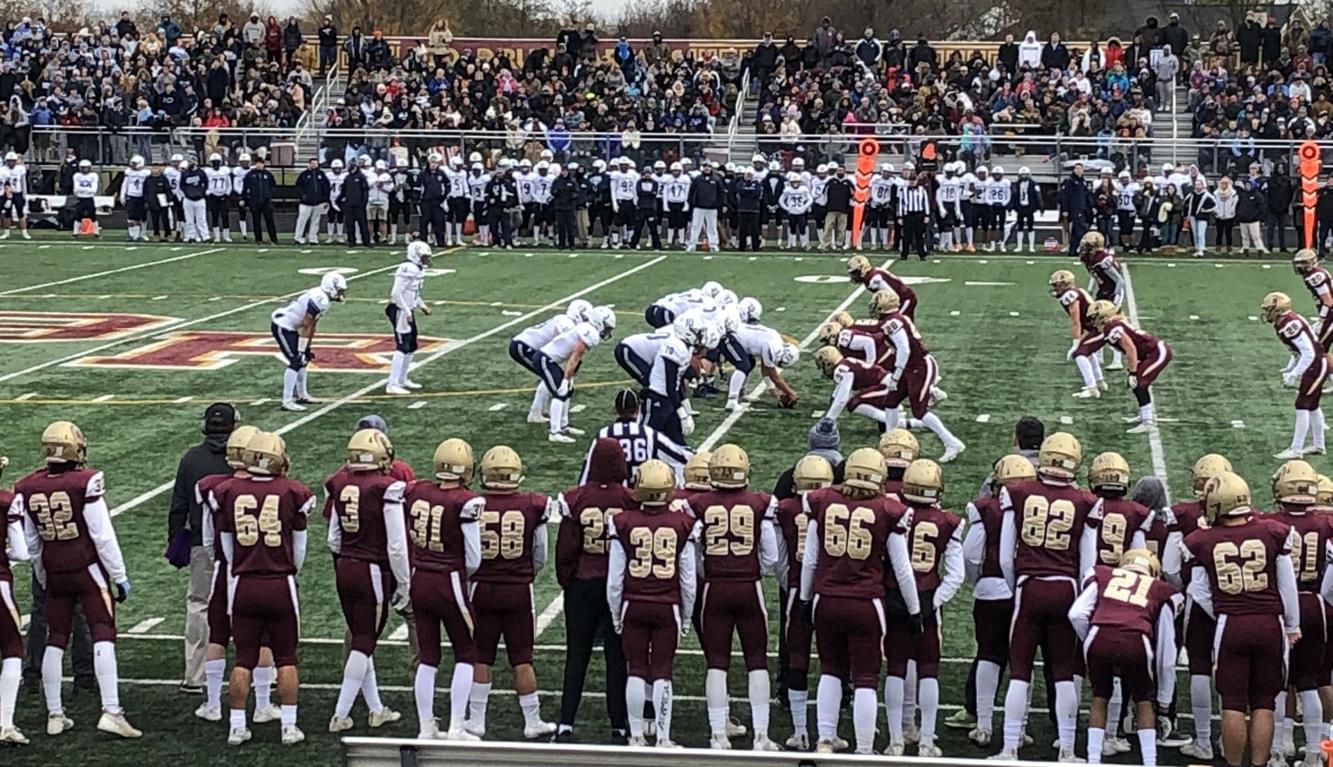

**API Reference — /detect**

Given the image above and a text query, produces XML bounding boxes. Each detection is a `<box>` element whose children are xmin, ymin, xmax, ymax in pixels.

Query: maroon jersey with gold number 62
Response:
<box><xmin>1185</xmin><ymin>516</ymin><xmax>1292</xmax><ymax>615</ymax></box>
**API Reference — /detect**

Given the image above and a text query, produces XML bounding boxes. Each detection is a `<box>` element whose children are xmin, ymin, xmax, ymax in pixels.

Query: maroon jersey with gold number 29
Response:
<box><xmin>688</xmin><ymin>490</ymin><xmax>774</xmax><ymax>580</ymax></box>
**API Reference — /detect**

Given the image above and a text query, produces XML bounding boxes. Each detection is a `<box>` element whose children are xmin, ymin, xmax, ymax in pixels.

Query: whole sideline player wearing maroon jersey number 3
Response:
<box><xmin>324</xmin><ymin>428</ymin><xmax>411</xmax><ymax>732</ymax></box>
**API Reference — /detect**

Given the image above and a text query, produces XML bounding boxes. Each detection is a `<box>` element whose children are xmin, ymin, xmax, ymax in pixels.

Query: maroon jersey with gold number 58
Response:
<box><xmin>472</xmin><ymin>492</ymin><xmax>551</xmax><ymax>584</ymax></box>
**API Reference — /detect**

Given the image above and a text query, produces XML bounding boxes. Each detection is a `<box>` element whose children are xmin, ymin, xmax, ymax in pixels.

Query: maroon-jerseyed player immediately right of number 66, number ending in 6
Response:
<box><xmin>884</xmin><ymin>459</ymin><xmax>964</xmax><ymax>758</ymax></box>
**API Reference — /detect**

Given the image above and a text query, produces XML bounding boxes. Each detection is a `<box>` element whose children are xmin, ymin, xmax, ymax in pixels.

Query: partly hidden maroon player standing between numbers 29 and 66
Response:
<box><xmin>777</xmin><ymin>455</ymin><xmax>845</xmax><ymax>751</ymax></box>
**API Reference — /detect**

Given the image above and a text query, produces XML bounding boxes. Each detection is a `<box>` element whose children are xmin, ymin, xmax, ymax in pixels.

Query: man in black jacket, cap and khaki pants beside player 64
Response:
<box><xmin>167</xmin><ymin>405</ymin><xmax>238</xmax><ymax>692</ymax></box>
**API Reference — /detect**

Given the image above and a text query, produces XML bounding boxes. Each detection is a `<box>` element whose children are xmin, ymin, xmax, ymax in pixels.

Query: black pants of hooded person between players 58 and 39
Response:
<box><xmin>560</xmin><ymin>578</ymin><xmax>629</xmax><ymax>732</ymax></box>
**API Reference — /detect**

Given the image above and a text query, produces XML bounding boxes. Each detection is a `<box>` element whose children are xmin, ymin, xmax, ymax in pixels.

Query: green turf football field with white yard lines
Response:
<box><xmin>0</xmin><ymin>237</ymin><xmax>1329</xmax><ymax>764</ymax></box>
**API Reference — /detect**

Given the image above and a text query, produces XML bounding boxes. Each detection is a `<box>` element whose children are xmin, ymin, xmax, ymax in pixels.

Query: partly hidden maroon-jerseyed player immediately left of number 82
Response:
<box><xmin>962</xmin><ymin>454</ymin><xmax>1037</xmax><ymax>746</ymax></box>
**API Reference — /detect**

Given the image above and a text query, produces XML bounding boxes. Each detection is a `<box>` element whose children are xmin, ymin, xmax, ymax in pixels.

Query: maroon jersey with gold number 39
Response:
<box><xmin>612</xmin><ymin>504</ymin><xmax>694</xmax><ymax>604</ymax></box>
